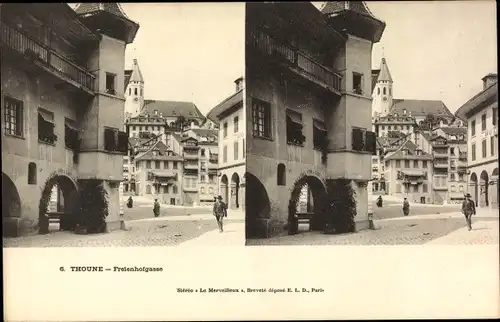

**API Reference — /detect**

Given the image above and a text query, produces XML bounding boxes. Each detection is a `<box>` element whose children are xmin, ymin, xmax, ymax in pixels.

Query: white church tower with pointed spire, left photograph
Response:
<box><xmin>125</xmin><ymin>59</ymin><xmax>144</xmax><ymax>119</ymax></box>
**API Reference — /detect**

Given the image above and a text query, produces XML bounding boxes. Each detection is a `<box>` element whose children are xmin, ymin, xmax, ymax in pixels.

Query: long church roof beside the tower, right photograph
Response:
<box><xmin>390</xmin><ymin>99</ymin><xmax>453</xmax><ymax>118</ymax></box>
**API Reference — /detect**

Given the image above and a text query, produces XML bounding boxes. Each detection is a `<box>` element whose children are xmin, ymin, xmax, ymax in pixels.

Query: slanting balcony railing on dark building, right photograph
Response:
<box><xmin>251</xmin><ymin>30</ymin><xmax>342</xmax><ymax>92</ymax></box>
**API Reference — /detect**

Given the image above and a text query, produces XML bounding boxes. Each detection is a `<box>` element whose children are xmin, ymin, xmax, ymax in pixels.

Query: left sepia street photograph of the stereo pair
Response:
<box><xmin>0</xmin><ymin>3</ymin><xmax>245</xmax><ymax>247</ymax></box>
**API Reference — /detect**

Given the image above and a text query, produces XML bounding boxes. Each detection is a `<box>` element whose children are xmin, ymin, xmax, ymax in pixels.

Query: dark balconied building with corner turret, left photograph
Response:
<box><xmin>0</xmin><ymin>3</ymin><xmax>138</xmax><ymax>236</ymax></box>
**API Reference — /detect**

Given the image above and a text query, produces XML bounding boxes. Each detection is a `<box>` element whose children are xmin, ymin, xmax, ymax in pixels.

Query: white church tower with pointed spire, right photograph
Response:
<box><xmin>372</xmin><ymin>58</ymin><xmax>393</xmax><ymax>117</ymax></box>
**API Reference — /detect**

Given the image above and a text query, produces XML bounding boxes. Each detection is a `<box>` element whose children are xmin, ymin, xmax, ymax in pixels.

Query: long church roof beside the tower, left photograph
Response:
<box><xmin>141</xmin><ymin>100</ymin><xmax>205</xmax><ymax>119</ymax></box>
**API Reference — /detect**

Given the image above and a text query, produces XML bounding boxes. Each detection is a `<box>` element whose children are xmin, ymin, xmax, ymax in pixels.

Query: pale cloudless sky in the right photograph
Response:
<box><xmin>314</xmin><ymin>0</ymin><xmax>497</xmax><ymax>112</ymax></box>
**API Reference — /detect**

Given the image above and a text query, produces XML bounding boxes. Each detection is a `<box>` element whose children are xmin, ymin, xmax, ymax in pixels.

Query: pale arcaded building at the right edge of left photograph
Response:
<box><xmin>207</xmin><ymin>78</ymin><xmax>247</xmax><ymax>210</ymax></box>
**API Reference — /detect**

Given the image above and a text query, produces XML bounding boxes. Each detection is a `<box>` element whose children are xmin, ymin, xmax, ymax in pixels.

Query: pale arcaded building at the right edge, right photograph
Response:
<box><xmin>456</xmin><ymin>74</ymin><xmax>499</xmax><ymax>209</ymax></box>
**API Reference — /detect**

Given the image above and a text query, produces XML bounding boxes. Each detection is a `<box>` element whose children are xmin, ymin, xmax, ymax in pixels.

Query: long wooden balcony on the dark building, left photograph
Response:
<box><xmin>0</xmin><ymin>23</ymin><xmax>95</xmax><ymax>95</ymax></box>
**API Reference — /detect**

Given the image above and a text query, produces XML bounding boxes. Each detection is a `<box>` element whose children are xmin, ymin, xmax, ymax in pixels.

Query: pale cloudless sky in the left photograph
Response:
<box><xmin>120</xmin><ymin>3</ymin><xmax>245</xmax><ymax>115</ymax></box>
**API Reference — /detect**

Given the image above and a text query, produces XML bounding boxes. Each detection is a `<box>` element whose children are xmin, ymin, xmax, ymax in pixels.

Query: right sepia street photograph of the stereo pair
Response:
<box><xmin>245</xmin><ymin>1</ymin><xmax>500</xmax><ymax>245</ymax></box>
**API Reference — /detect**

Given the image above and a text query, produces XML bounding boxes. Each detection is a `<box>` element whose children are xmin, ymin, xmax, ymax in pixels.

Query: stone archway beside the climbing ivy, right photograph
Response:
<box><xmin>288</xmin><ymin>175</ymin><xmax>328</xmax><ymax>233</ymax></box>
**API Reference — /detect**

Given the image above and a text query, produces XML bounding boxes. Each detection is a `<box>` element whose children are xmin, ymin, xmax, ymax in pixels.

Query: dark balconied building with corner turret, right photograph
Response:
<box><xmin>245</xmin><ymin>1</ymin><xmax>385</xmax><ymax>237</ymax></box>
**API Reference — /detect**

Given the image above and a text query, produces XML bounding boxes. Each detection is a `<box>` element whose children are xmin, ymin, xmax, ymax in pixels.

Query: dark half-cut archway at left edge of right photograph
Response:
<box><xmin>245</xmin><ymin>172</ymin><xmax>271</xmax><ymax>238</ymax></box>
